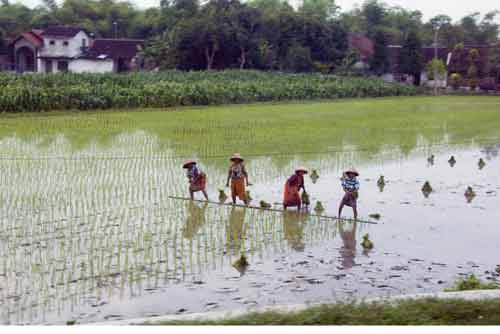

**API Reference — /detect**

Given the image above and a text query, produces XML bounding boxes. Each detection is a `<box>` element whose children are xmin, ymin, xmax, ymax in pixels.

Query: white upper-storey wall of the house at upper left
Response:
<box><xmin>40</xmin><ymin>31</ymin><xmax>90</xmax><ymax>58</ymax></box>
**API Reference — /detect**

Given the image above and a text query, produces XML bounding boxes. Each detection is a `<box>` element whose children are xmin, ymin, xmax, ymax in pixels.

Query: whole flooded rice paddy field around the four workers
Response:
<box><xmin>0</xmin><ymin>97</ymin><xmax>500</xmax><ymax>324</ymax></box>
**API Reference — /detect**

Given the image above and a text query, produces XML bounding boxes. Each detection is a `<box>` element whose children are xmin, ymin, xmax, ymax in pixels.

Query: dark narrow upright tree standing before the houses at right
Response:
<box><xmin>400</xmin><ymin>30</ymin><xmax>423</xmax><ymax>86</ymax></box>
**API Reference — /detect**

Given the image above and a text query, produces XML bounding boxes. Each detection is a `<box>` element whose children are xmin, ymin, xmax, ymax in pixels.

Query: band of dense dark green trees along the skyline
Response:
<box><xmin>0</xmin><ymin>0</ymin><xmax>500</xmax><ymax>76</ymax></box>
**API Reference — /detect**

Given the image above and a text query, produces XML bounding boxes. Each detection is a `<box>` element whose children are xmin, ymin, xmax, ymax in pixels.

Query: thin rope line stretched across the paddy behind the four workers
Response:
<box><xmin>0</xmin><ymin>139</ymin><xmax>495</xmax><ymax>161</ymax></box>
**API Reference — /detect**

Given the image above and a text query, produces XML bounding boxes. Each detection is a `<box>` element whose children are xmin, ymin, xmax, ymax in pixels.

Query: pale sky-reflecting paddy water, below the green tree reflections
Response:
<box><xmin>0</xmin><ymin>108</ymin><xmax>500</xmax><ymax>324</ymax></box>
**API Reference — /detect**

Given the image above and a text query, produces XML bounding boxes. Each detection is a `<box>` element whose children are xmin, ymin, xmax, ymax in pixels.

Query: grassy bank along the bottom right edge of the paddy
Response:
<box><xmin>149</xmin><ymin>299</ymin><xmax>500</xmax><ymax>325</ymax></box>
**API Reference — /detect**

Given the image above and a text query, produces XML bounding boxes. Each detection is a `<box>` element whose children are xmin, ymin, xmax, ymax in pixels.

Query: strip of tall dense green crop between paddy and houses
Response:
<box><xmin>0</xmin><ymin>71</ymin><xmax>416</xmax><ymax>112</ymax></box>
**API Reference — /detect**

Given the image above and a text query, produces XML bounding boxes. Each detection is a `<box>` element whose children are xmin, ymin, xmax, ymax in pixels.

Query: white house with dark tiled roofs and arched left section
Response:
<box><xmin>11</xmin><ymin>26</ymin><xmax>144</xmax><ymax>73</ymax></box>
